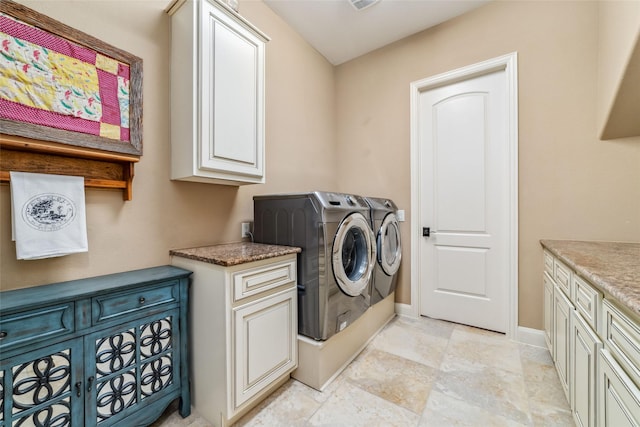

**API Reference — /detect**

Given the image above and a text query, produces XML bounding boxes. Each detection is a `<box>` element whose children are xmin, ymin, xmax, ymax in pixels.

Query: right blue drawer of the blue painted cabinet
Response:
<box><xmin>91</xmin><ymin>282</ymin><xmax>179</xmax><ymax>325</ymax></box>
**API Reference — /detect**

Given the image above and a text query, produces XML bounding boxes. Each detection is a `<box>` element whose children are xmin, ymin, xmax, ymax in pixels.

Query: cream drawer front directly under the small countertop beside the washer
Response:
<box><xmin>232</xmin><ymin>258</ymin><xmax>296</xmax><ymax>301</ymax></box>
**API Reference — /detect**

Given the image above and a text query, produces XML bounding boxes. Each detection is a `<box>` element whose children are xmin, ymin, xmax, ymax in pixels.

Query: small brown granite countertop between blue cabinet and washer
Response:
<box><xmin>169</xmin><ymin>242</ymin><xmax>302</xmax><ymax>267</ymax></box>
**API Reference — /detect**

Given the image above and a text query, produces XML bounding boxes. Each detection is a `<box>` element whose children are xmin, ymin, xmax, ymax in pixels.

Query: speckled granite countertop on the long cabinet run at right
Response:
<box><xmin>540</xmin><ymin>240</ymin><xmax>640</xmax><ymax>315</ymax></box>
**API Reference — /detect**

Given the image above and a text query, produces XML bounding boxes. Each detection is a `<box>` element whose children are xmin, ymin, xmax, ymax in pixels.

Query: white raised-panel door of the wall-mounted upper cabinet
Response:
<box><xmin>199</xmin><ymin>1</ymin><xmax>265</xmax><ymax>178</ymax></box>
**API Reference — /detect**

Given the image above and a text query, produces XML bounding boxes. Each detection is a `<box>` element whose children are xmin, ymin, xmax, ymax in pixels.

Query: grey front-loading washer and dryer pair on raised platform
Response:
<box><xmin>254</xmin><ymin>191</ymin><xmax>401</xmax><ymax>340</ymax></box>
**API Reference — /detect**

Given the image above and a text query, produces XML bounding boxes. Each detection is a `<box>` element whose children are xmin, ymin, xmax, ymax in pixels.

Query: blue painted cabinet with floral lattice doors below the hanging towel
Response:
<box><xmin>0</xmin><ymin>266</ymin><xmax>191</xmax><ymax>427</ymax></box>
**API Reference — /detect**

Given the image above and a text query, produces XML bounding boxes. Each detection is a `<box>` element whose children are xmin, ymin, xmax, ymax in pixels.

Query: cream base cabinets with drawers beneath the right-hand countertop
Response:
<box><xmin>543</xmin><ymin>250</ymin><xmax>640</xmax><ymax>427</ymax></box>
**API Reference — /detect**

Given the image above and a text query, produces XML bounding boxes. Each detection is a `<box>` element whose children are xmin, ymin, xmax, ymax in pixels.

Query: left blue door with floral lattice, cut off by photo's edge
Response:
<box><xmin>0</xmin><ymin>339</ymin><xmax>84</xmax><ymax>427</ymax></box>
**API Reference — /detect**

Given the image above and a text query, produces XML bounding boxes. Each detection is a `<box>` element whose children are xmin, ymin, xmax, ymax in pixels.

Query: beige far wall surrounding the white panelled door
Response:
<box><xmin>336</xmin><ymin>1</ymin><xmax>640</xmax><ymax>329</ymax></box>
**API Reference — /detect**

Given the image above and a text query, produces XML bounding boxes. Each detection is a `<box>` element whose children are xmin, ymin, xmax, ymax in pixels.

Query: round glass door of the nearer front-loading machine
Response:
<box><xmin>332</xmin><ymin>212</ymin><xmax>376</xmax><ymax>297</ymax></box>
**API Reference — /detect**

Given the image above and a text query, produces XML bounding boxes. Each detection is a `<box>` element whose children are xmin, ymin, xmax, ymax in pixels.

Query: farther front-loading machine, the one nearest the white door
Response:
<box><xmin>364</xmin><ymin>197</ymin><xmax>402</xmax><ymax>305</ymax></box>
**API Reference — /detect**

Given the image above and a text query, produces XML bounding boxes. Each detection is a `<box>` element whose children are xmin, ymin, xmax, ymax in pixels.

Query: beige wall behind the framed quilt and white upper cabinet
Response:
<box><xmin>0</xmin><ymin>0</ymin><xmax>337</xmax><ymax>290</ymax></box>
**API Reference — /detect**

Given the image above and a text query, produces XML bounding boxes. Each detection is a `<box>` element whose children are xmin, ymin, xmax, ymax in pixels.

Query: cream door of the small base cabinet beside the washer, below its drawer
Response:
<box><xmin>232</xmin><ymin>288</ymin><xmax>297</xmax><ymax>409</ymax></box>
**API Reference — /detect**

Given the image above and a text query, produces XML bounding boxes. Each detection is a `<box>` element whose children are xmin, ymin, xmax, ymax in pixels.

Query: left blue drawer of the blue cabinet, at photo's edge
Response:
<box><xmin>0</xmin><ymin>302</ymin><xmax>74</xmax><ymax>350</ymax></box>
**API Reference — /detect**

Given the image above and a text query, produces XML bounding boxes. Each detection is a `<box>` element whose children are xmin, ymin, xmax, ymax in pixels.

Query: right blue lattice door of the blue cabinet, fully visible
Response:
<box><xmin>85</xmin><ymin>310</ymin><xmax>180</xmax><ymax>426</ymax></box>
